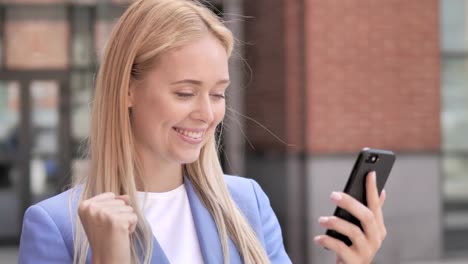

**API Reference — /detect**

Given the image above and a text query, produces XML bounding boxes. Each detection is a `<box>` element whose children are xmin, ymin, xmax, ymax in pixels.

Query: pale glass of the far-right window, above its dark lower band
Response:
<box><xmin>441</xmin><ymin>0</ymin><xmax>468</xmax><ymax>202</ymax></box>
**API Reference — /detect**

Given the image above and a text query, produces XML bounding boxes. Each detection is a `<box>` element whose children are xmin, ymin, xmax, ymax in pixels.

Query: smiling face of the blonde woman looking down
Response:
<box><xmin>129</xmin><ymin>34</ymin><xmax>229</xmax><ymax>164</ymax></box>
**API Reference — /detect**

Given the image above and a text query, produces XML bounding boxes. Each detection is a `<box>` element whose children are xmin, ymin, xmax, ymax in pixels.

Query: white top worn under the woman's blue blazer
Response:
<box><xmin>137</xmin><ymin>184</ymin><xmax>203</xmax><ymax>264</ymax></box>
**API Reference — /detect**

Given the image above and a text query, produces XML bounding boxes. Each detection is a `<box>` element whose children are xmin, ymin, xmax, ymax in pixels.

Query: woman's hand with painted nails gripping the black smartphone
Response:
<box><xmin>314</xmin><ymin>172</ymin><xmax>387</xmax><ymax>264</ymax></box>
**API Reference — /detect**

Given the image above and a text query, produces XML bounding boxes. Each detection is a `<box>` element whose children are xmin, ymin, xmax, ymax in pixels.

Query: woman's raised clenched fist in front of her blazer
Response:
<box><xmin>78</xmin><ymin>193</ymin><xmax>138</xmax><ymax>264</ymax></box>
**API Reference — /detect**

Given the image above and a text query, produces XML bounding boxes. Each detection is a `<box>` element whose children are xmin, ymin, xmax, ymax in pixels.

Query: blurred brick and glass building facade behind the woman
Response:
<box><xmin>0</xmin><ymin>0</ymin><xmax>468</xmax><ymax>264</ymax></box>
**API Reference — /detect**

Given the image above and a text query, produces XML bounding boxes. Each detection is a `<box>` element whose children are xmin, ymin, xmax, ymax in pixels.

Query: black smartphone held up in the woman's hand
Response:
<box><xmin>326</xmin><ymin>148</ymin><xmax>395</xmax><ymax>246</ymax></box>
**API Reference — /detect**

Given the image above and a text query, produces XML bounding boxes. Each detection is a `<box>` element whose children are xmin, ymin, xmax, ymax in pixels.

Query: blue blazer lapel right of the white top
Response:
<box><xmin>184</xmin><ymin>177</ymin><xmax>242</xmax><ymax>264</ymax></box>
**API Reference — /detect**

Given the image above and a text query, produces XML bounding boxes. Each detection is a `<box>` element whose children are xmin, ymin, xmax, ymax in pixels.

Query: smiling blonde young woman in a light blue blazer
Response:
<box><xmin>19</xmin><ymin>0</ymin><xmax>385</xmax><ymax>264</ymax></box>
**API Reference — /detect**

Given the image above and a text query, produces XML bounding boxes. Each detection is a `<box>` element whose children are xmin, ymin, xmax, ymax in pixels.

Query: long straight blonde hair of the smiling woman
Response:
<box><xmin>73</xmin><ymin>0</ymin><xmax>269</xmax><ymax>263</ymax></box>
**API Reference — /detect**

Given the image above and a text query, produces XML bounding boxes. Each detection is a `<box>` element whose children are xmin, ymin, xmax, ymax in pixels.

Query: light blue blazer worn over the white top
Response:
<box><xmin>19</xmin><ymin>176</ymin><xmax>291</xmax><ymax>264</ymax></box>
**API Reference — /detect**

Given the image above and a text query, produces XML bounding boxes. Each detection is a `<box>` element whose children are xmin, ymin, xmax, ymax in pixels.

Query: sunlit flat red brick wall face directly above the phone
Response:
<box><xmin>305</xmin><ymin>0</ymin><xmax>440</xmax><ymax>153</ymax></box>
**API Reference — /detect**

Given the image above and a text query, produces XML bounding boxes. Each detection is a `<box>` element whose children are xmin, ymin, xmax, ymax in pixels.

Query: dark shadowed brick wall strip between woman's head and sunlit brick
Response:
<box><xmin>243</xmin><ymin>0</ymin><xmax>287</xmax><ymax>151</ymax></box>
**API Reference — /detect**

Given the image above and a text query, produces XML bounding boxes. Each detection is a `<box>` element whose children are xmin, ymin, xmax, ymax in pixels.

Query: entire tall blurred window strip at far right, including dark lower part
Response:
<box><xmin>440</xmin><ymin>0</ymin><xmax>468</xmax><ymax>255</ymax></box>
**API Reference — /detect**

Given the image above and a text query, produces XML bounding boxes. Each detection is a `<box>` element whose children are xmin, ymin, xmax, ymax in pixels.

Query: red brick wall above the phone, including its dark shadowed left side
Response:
<box><xmin>245</xmin><ymin>0</ymin><xmax>440</xmax><ymax>154</ymax></box>
